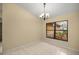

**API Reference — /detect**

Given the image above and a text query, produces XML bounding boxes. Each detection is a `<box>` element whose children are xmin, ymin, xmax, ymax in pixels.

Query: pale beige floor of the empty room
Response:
<box><xmin>4</xmin><ymin>42</ymin><xmax>79</xmax><ymax>55</ymax></box>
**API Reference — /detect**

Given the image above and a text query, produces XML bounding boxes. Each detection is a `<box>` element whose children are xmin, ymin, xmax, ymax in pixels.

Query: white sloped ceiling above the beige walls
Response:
<box><xmin>17</xmin><ymin>3</ymin><xmax>79</xmax><ymax>18</ymax></box>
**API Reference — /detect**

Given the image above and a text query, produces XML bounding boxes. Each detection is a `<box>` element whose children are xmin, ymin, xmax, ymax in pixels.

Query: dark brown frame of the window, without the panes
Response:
<box><xmin>46</xmin><ymin>20</ymin><xmax>68</xmax><ymax>41</ymax></box>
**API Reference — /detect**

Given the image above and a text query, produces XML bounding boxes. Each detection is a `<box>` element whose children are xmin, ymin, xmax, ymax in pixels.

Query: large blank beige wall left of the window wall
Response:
<box><xmin>3</xmin><ymin>4</ymin><xmax>42</xmax><ymax>51</ymax></box>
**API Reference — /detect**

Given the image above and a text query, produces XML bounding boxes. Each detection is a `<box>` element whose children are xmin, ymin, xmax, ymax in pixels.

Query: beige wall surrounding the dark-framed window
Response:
<box><xmin>43</xmin><ymin>12</ymin><xmax>79</xmax><ymax>50</ymax></box>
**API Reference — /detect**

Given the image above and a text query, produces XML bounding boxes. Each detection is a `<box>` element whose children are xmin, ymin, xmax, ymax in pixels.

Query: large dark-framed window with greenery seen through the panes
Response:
<box><xmin>46</xmin><ymin>20</ymin><xmax>68</xmax><ymax>41</ymax></box>
